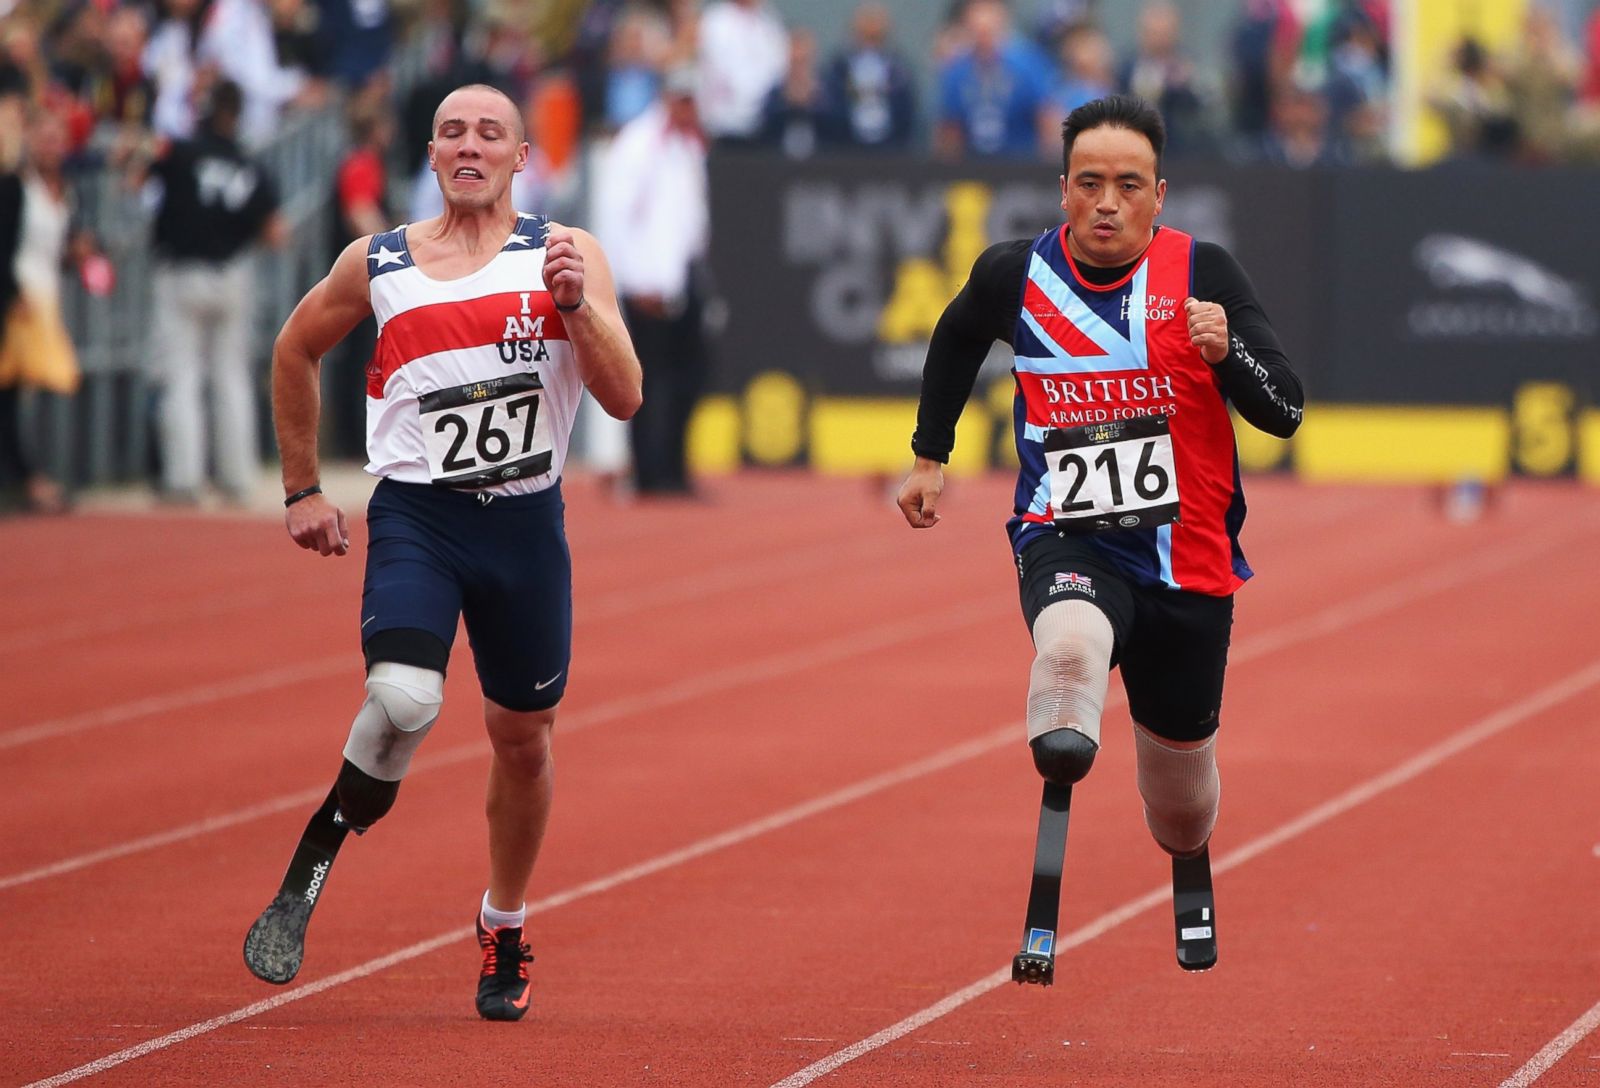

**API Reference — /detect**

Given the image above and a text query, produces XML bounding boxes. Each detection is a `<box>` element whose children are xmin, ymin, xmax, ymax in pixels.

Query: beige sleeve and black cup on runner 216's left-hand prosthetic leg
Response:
<box><xmin>1027</xmin><ymin>600</ymin><xmax>1115</xmax><ymax>786</ymax></box>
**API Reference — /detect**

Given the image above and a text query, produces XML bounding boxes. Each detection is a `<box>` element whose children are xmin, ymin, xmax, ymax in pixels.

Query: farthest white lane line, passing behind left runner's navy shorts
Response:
<box><xmin>0</xmin><ymin>537</ymin><xmax>908</xmax><ymax>750</ymax></box>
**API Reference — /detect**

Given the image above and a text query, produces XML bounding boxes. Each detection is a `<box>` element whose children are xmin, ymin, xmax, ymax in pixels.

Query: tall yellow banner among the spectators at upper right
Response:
<box><xmin>1390</xmin><ymin>0</ymin><xmax>1528</xmax><ymax>166</ymax></box>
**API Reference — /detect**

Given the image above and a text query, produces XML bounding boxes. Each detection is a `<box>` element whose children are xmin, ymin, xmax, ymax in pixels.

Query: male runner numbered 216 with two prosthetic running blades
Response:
<box><xmin>899</xmin><ymin>96</ymin><xmax>1304</xmax><ymax>984</ymax></box>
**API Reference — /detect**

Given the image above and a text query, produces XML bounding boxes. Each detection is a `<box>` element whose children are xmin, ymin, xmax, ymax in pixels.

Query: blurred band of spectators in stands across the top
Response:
<box><xmin>0</xmin><ymin>0</ymin><xmax>1600</xmax><ymax>173</ymax></box>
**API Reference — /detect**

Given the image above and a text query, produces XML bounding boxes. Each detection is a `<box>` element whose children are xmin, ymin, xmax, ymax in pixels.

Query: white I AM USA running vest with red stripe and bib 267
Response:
<box><xmin>366</xmin><ymin>214</ymin><xmax>582</xmax><ymax>494</ymax></box>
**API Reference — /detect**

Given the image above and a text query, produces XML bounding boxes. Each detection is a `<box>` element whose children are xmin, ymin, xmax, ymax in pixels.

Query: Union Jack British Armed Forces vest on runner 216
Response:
<box><xmin>1006</xmin><ymin>226</ymin><xmax>1251</xmax><ymax>597</ymax></box>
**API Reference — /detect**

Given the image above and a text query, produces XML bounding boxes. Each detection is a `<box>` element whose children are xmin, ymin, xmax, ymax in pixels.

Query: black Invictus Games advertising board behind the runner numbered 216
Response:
<box><xmin>710</xmin><ymin>152</ymin><xmax>1326</xmax><ymax>397</ymax></box>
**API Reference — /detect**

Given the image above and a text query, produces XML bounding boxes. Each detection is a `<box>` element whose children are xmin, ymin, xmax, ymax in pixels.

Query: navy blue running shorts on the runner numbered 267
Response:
<box><xmin>362</xmin><ymin>480</ymin><xmax>573</xmax><ymax>710</ymax></box>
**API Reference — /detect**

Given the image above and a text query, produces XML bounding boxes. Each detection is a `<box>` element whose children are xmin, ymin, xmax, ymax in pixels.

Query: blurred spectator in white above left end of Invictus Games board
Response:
<box><xmin>698</xmin><ymin>0</ymin><xmax>789</xmax><ymax>142</ymax></box>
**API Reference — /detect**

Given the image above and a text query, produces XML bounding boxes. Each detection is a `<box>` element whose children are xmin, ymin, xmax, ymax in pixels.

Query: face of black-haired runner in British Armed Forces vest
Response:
<box><xmin>1061</xmin><ymin>125</ymin><xmax>1166</xmax><ymax>267</ymax></box>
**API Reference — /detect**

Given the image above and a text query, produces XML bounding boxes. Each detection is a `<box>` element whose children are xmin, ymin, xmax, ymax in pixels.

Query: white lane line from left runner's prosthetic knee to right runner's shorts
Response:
<box><xmin>0</xmin><ymin>597</ymin><xmax>1013</xmax><ymax>891</ymax></box>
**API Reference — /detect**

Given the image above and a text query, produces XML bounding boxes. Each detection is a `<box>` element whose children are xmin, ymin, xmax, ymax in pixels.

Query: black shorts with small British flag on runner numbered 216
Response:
<box><xmin>1016</xmin><ymin>534</ymin><xmax>1234</xmax><ymax>741</ymax></box>
